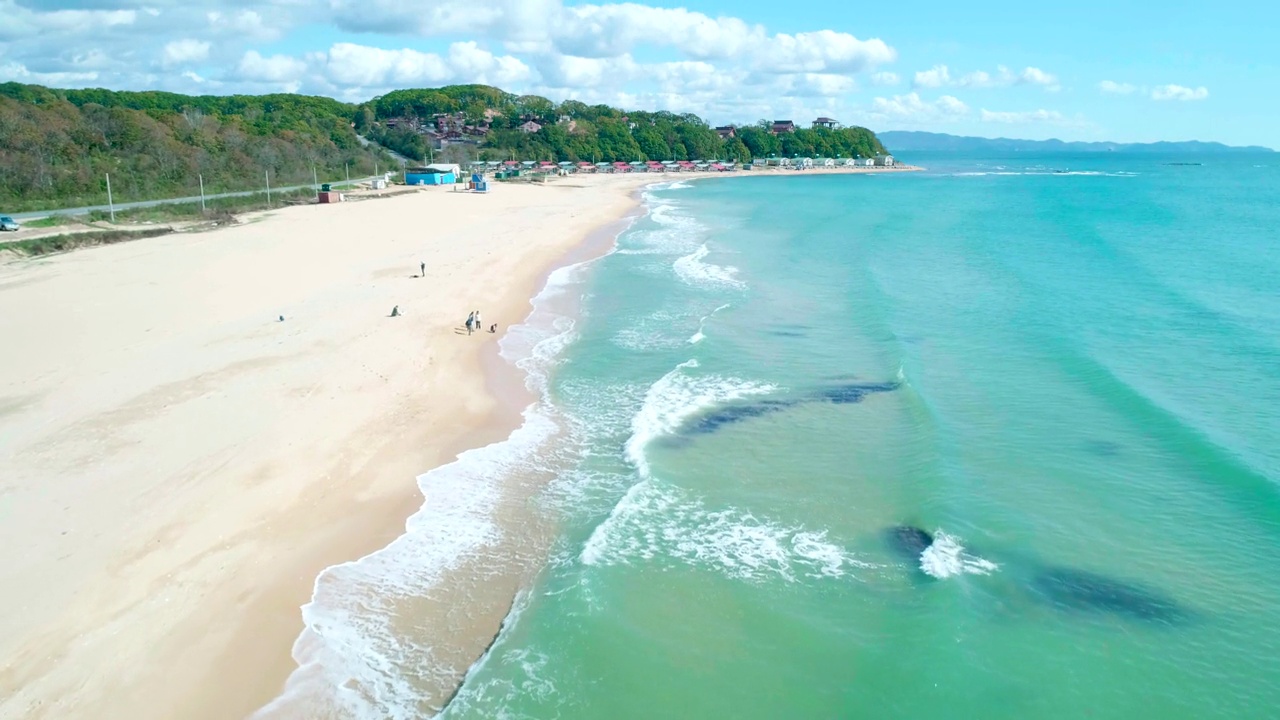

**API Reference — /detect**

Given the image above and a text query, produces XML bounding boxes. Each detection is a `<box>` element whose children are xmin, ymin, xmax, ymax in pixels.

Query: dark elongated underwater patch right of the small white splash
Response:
<box><xmin>1032</xmin><ymin>568</ymin><xmax>1187</xmax><ymax>623</ymax></box>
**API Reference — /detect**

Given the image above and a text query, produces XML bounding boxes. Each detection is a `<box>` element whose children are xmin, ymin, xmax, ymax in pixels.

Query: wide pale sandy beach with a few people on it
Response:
<box><xmin>0</xmin><ymin>163</ymin><xmax>911</xmax><ymax>719</ymax></box>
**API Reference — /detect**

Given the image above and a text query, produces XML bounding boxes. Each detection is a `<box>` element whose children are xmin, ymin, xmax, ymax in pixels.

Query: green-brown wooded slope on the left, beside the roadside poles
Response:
<box><xmin>0</xmin><ymin>83</ymin><xmax>389</xmax><ymax>213</ymax></box>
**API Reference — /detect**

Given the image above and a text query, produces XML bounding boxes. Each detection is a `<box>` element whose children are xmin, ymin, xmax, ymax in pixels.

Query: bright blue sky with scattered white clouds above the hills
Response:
<box><xmin>0</xmin><ymin>0</ymin><xmax>1280</xmax><ymax>147</ymax></box>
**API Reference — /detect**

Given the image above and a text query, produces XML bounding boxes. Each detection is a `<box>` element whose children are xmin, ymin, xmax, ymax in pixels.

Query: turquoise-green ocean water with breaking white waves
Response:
<box><xmin>257</xmin><ymin>155</ymin><xmax>1280</xmax><ymax>720</ymax></box>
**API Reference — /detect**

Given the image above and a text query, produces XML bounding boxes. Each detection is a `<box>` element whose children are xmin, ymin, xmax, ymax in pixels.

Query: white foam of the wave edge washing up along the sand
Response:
<box><xmin>252</xmin><ymin>203</ymin><xmax>629</xmax><ymax>720</ymax></box>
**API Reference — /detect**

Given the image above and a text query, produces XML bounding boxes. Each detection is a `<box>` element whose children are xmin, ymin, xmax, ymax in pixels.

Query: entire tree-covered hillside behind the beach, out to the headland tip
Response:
<box><xmin>0</xmin><ymin>82</ymin><xmax>884</xmax><ymax>213</ymax></box>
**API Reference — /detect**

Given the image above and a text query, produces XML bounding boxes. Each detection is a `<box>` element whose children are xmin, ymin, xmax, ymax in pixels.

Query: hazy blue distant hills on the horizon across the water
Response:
<box><xmin>876</xmin><ymin>131</ymin><xmax>1274</xmax><ymax>154</ymax></box>
